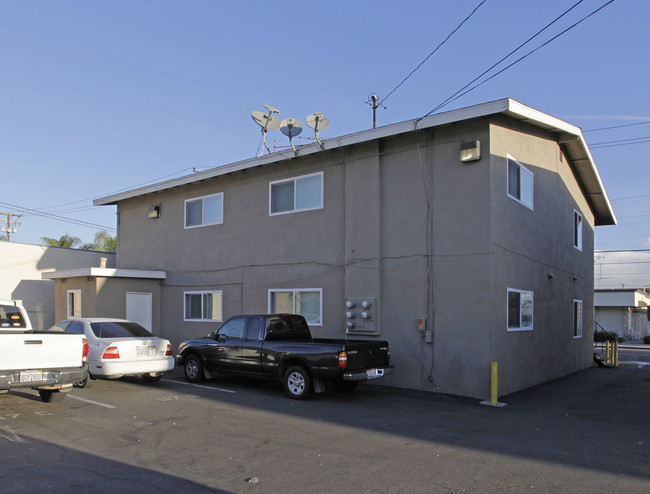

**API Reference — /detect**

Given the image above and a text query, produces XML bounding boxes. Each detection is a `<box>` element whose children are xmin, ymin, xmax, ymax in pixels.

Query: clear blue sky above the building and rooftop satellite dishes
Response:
<box><xmin>0</xmin><ymin>0</ymin><xmax>650</xmax><ymax>250</ymax></box>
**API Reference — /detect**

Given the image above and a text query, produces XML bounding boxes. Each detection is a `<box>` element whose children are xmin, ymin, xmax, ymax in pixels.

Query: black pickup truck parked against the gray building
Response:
<box><xmin>176</xmin><ymin>314</ymin><xmax>393</xmax><ymax>400</ymax></box>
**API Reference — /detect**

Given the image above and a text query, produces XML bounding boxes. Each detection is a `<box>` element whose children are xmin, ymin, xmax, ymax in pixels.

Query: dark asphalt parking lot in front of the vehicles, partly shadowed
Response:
<box><xmin>0</xmin><ymin>350</ymin><xmax>650</xmax><ymax>494</ymax></box>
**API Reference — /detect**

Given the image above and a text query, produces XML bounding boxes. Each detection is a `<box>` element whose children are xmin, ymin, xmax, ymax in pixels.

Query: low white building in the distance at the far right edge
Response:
<box><xmin>594</xmin><ymin>288</ymin><xmax>650</xmax><ymax>340</ymax></box>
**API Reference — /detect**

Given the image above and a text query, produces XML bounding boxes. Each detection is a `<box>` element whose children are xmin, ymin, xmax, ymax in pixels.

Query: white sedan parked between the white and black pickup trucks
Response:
<box><xmin>50</xmin><ymin>317</ymin><xmax>174</xmax><ymax>387</ymax></box>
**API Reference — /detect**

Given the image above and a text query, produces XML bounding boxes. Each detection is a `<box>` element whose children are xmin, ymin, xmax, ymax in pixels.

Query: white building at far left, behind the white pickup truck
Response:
<box><xmin>0</xmin><ymin>241</ymin><xmax>115</xmax><ymax>330</ymax></box>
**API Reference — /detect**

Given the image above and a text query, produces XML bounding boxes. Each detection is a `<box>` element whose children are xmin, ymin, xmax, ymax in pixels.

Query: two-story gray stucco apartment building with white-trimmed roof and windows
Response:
<box><xmin>71</xmin><ymin>99</ymin><xmax>616</xmax><ymax>398</ymax></box>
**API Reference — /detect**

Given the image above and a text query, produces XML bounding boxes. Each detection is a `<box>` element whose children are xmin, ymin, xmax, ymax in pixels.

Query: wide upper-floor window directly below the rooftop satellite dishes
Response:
<box><xmin>269</xmin><ymin>172</ymin><xmax>323</xmax><ymax>215</ymax></box>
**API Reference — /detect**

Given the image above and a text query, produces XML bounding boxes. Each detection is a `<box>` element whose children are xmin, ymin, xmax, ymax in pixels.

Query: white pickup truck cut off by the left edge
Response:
<box><xmin>0</xmin><ymin>299</ymin><xmax>88</xmax><ymax>403</ymax></box>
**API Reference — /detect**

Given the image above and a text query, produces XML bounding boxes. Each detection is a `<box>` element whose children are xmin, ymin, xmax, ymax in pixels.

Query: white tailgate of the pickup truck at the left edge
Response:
<box><xmin>0</xmin><ymin>331</ymin><xmax>83</xmax><ymax>369</ymax></box>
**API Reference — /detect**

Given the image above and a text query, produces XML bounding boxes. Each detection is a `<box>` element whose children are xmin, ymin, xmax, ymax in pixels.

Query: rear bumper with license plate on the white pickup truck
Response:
<box><xmin>0</xmin><ymin>362</ymin><xmax>88</xmax><ymax>390</ymax></box>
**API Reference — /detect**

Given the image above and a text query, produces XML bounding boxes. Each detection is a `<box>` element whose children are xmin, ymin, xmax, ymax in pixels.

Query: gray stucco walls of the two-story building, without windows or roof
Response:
<box><xmin>109</xmin><ymin>118</ymin><xmax>594</xmax><ymax>398</ymax></box>
